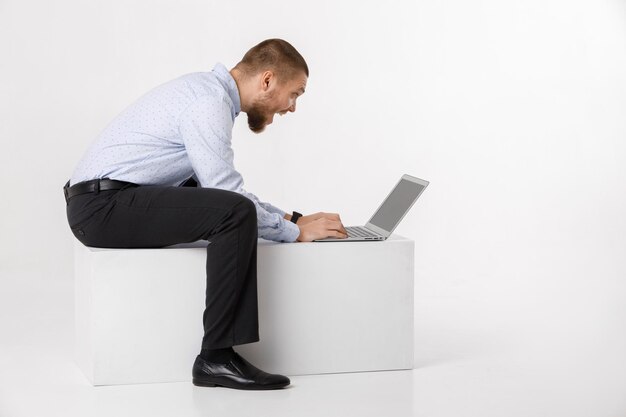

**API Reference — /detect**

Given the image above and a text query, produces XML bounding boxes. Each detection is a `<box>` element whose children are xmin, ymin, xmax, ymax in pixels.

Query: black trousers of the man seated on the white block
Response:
<box><xmin>67</xmin><ymin>181</ymin><xmax>259</xmax><ymax>349</ymax></box>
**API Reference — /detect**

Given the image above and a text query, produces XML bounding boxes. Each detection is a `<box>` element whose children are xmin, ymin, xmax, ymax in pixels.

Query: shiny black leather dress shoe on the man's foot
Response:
<box><xmin>192</xmin><ymin>352</ymin><xmax>291</xmax><ymax>390</ymax></box>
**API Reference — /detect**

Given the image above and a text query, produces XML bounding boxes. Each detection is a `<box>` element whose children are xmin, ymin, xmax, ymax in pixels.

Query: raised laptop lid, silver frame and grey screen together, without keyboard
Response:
<box><xmin>365</xmin><ymin>174</ymin><xmax>429</xmax><ymax>237</ymax></box>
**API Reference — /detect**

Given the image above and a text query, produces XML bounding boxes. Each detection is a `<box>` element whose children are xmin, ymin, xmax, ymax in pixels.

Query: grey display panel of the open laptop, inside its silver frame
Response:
<box><xmin>369</xmin><ymin>179</ymin><xmax>426</xmax><ymax>232</ymax></box>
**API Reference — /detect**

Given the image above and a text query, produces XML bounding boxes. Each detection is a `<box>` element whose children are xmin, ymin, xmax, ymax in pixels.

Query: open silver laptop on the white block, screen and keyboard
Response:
<box><xmin>313</xmin><ymin>174</ymin><xmax>429</xmax><ymax>242</ymax></box>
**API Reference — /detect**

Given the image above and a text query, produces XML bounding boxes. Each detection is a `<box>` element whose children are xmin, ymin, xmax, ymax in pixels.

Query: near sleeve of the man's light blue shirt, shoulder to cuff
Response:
<box><xmin>179</xmin><ymin>92</ymin><xmax>300</xmax><ymax>242</ymax></box>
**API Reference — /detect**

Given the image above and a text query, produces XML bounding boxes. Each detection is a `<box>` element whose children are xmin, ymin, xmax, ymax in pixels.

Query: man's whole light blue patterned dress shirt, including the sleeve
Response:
<box><xmin>70</xmin><ymin>63</ymin><xmax>300</xmax><ymax>242</ymax></box>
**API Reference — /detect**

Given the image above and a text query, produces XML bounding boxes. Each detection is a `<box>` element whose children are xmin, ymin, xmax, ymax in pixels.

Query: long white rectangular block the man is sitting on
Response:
<box><xmin>75</xmin><ymin>235</ymin><xmax>414</xmax><ymax>385</ymax></box>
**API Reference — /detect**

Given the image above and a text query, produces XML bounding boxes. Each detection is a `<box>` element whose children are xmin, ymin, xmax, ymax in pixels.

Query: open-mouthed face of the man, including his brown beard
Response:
<box><xmin>247</xmin><ymin>71</ymin><xmax>307</xmax><ymax>133</ymax></box>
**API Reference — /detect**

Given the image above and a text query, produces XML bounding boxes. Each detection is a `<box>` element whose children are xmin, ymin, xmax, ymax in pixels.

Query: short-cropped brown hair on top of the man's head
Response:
<box><xmin>235</xmin><ymin>39</ymin><xmax>309</xmax><ymax>79</ymax></box>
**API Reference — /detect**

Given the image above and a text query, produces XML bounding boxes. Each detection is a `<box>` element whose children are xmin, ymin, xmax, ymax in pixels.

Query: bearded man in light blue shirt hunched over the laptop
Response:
<box><xmin>64</xmin><ymin>39</ymin><xmax>347</xmax><ymax>389</ymax></box>
